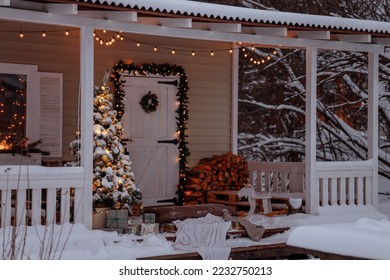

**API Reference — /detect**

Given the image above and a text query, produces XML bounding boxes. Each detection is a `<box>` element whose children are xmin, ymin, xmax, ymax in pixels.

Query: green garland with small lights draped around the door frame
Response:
<box><xmin>111</xmin><ymin>61</ymin><xmax>190</xmax><ymax>205</ymax></box>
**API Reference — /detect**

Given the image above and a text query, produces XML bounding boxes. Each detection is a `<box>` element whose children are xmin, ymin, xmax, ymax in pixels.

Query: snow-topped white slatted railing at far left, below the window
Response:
<box><xmin>0</xmin><ymin>165</ymin><xmax>85</xmax><ymax>227</ymax></box>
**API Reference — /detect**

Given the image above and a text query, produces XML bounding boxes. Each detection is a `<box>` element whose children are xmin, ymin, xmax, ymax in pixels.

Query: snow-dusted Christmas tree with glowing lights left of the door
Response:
<box><xmin>67</xmin><ymin>73</ymin><xmax>142</xmax><ymax>213</ymax></box>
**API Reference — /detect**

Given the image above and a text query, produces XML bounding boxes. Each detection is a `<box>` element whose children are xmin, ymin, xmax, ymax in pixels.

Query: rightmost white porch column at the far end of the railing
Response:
<box><xmin>366</xmin><ymin>52</ymin><xmax>379</xmax><ymax>205</ymax></box>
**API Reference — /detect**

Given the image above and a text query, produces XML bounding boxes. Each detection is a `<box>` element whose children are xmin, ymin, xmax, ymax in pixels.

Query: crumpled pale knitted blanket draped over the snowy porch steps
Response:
<box><xmin>173</xmin><ymin>214</ymin><xmax>231</xmax><ymax>260</ymax></box>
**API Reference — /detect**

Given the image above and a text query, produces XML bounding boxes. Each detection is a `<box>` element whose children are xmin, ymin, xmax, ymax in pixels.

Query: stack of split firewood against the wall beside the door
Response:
<box><xmin>184</xmin><ymin>153</ymin><xmax>249</xmax><ymax>204</ymax></box>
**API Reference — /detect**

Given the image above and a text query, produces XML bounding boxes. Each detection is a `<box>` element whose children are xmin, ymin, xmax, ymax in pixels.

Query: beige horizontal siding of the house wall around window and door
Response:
<box><xmin>0</xmin><ymin>22</ymin><xmax>231</xmax><ymax>166</ymax></box>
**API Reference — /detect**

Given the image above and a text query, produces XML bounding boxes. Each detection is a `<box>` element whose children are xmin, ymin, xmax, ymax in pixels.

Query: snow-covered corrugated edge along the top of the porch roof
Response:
<box><xmin>77</xmin><ymin>0</ymin><xmax>390</xmax><ymax>35</ymax></box>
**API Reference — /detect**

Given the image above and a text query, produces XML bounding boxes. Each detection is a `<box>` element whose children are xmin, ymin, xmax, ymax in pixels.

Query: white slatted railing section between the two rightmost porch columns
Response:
<box><xmin>315</xmin><ymin>160</ymin><xmax>373</xmax><ymax>206</ymax></box>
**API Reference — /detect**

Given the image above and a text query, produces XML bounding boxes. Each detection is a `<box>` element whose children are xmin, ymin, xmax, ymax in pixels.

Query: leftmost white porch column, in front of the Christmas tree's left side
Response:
<box><xmin>80</xmin><ymin>26</ymin><xmax>94</xmax><ymax>229</ymax></box>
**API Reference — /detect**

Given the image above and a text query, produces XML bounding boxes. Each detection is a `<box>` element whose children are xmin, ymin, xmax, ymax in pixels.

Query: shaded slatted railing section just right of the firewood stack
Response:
<box><xmin>248</xmin><ymin>161</ymin><xmax>305</xmax><ymax>192</ymax></box>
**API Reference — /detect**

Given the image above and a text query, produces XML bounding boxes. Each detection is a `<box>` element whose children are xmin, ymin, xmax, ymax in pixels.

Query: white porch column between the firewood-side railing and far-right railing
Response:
<box><xmin>305</xmin><ymin>48</ymin><xmax>319</xmax><ymax>214</ymax></box>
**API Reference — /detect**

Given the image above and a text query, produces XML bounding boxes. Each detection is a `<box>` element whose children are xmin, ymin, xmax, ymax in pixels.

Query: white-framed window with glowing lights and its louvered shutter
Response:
<box><xmin>0</xmin><ymin>63</ymin><xmax>63</xmax><ymax>157</ymax></box>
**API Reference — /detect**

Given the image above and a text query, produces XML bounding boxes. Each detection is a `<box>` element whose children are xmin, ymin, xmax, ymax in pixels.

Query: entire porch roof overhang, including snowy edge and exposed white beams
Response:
<box><xmin>0</xmin><ymin>0</ymin><xmax>390</xmax><ymax>50</ymax></box>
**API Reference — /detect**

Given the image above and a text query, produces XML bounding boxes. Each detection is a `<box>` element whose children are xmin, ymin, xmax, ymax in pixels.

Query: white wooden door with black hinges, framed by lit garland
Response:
<box><xmin>122</xmin><ymin>76</ymin><xmax>179</xmax><ymax>206</ymax></box>
